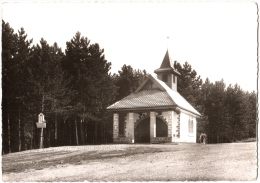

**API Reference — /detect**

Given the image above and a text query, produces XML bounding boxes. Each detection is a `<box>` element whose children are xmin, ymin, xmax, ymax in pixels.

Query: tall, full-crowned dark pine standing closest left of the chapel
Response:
<box><xmin>62</xmin><ymin>32</ymin><xmax>115</xmax><ymax>144</ymax></box>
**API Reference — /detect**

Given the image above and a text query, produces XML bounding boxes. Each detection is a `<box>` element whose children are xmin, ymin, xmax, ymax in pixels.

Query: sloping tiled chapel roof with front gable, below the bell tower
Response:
<box><xmin>107</xmin><ymin>75</ymin><xmax>200</xmax><ymax>116</ymax></box>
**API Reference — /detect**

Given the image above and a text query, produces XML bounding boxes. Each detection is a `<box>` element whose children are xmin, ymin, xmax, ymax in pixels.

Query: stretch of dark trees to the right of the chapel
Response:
<box><xmin>174</xmin><ymin>62</ymin><xmax>257</xmax><ymax>143</ymax></box>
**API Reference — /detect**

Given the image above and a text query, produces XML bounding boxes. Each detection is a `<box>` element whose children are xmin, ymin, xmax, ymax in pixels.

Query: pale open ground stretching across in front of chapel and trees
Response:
<box><xmin>2</xmin><ymin>142</ymin><xmax>257</xmax><ymax>182</ymax></box>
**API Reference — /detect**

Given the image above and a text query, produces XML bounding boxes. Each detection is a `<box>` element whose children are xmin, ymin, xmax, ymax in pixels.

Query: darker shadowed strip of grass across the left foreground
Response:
<box><xmin>2</xmin><ymin>147</ymin><xmax>165</xmax><ymax>173</ymax></box>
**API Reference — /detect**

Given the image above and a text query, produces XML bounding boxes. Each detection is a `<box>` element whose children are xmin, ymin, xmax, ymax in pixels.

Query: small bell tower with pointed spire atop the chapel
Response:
<box><xmin>154</xmin><ymin>50</ymin><xmax>181</xmax><ymax>92</ymax></box>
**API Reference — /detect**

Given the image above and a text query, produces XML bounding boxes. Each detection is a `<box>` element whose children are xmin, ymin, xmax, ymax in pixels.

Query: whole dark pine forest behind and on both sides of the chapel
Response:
<box><xmin>2</xmin><ymin>21</ymin><xmax>257</xmax><ymax>154</ymax></box>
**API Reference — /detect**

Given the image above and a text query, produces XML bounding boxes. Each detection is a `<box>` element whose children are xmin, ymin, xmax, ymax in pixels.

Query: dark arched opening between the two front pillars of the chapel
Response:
<box><xmin>135</xmin><ymin>118</ymin><xmax>150</xmax><ymax>143</ymax></box>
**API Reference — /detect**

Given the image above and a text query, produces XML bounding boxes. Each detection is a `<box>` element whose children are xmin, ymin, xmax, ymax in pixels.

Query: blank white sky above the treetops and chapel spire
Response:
<box><xmin>1</xmin><ymin>0</ymin><xmax>258</xmax><ymax>92</ymax></box>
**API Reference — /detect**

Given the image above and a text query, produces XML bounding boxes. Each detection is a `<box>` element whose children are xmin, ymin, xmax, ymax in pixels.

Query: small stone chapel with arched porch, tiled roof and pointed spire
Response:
<box><xmin>107</xmin><ymin>50</ymin><xmax>201</xmax><ymax>143</ymax></box>
